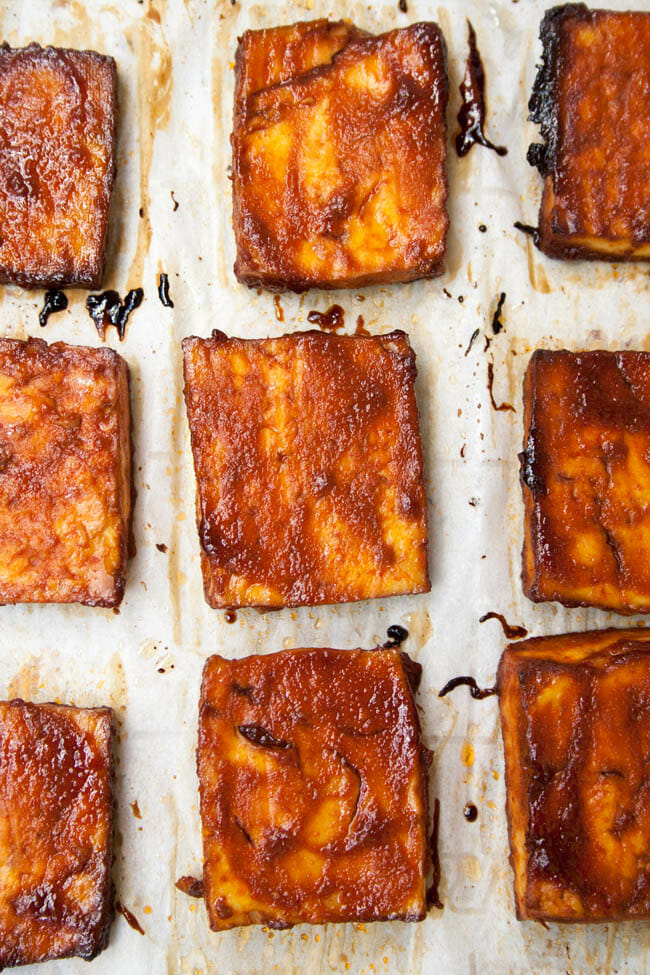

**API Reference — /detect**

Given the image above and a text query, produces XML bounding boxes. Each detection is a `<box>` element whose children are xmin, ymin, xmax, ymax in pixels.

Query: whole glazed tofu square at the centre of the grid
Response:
<box><xmin>183</xmin><ymin>331</ymin><xmax>430</xmax><ymax>607</ymax></box>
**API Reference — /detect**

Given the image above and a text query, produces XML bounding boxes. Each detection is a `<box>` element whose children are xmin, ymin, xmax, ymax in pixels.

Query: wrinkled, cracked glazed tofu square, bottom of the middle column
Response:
<box><xmin>197</xmin><ymin>649</ymin><xmax>430</xmax><ymax>931</ymax></box>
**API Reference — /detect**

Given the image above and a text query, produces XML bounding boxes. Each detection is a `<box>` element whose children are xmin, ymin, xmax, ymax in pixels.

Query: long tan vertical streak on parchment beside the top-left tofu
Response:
<box><xmin>126</xmin><ymin>2</ymin><xmax>173</xmax><ymax>290</ymax></box>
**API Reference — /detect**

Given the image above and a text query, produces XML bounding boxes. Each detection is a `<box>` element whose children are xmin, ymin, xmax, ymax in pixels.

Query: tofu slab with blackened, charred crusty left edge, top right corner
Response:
<box><xmin>528</xmin><ymin>4</ymin><xmax>650</xmax><ymax>261</ymax></box>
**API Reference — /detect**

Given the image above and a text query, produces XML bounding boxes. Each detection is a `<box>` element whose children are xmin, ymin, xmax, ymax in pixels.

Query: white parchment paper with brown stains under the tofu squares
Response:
<box><xmin>0</xmin><ymin>0</ymin><xmax>650</xmax><ymax>975</ymax></box>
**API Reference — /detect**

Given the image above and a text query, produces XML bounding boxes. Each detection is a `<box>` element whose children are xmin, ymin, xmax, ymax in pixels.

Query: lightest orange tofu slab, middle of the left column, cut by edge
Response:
<box><xmin>0</xmin><ymin>339</ymin><xmax>131</xmax><ymax>606</ymax></box>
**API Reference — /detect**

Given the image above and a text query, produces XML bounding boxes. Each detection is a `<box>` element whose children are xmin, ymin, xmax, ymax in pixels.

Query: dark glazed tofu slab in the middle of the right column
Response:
<box><xmin>520</xmin><ymin>350</ymin><xmax>650</xmax><ymax>614</ymax></box>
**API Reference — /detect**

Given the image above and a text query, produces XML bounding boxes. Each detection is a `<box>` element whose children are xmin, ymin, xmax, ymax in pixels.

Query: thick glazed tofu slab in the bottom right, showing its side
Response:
<box><xmin>497</xmin><ymin>629</ymin><xmax>650</xmax><ymax>921</ymax></box>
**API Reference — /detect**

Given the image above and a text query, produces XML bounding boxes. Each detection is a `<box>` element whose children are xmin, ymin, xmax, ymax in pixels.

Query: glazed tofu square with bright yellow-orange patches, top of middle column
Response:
<box><xmin>232</xmin><ymin>20</ymin><xmax>448</xmax><ymax>291</ymax></box>
